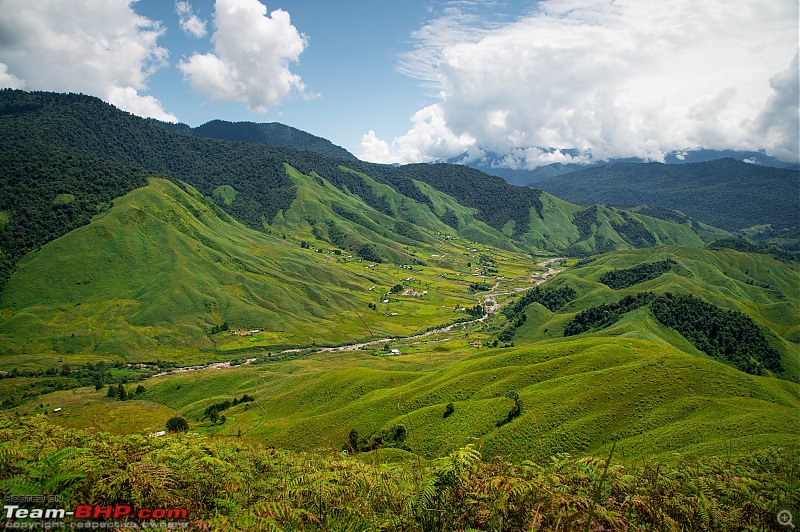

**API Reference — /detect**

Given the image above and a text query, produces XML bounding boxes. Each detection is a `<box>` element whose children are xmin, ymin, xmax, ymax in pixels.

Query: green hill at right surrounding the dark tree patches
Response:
<box><xmin>515</xmin><ymin>246</ymin><xmax>800</xmax><ymax>381</ymax></box>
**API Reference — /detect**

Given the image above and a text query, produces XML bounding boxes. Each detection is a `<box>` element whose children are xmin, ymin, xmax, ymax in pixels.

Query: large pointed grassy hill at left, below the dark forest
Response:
<box><xmin>0</xmin><ymin>179</ymin><xmax>484</xmax><ymax>360</ymax></box>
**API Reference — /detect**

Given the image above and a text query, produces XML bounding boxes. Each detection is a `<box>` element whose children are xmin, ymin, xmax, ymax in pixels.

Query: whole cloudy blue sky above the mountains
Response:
<box><xmin>0</xmin><ymin>0</ymin><xmax>800</xmax><ymax>169</ymax></box>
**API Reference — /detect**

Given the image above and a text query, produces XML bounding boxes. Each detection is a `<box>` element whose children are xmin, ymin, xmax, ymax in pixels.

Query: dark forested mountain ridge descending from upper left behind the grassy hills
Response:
<box><xmin>0</xmin><ymin>89</ymin><xmax>701</xmax><ymax>282</ymax></box>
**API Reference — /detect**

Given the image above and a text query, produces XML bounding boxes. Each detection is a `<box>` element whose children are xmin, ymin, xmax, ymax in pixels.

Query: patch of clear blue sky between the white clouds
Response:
<box><xmin>134</xmin><ymin>0</ymin><xmax>450</xmax><ymax>153</ymax></box>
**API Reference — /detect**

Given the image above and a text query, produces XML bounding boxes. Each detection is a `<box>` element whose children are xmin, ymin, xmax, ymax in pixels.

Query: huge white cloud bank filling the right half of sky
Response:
<box><xmin>362</xmin><ymin>0</ymin><xmax>798</xmax><ymax>168</ymax></box>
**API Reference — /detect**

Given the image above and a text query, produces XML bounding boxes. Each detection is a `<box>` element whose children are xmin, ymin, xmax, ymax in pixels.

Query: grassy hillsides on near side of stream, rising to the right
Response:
<box><xmin>6</xmin><ymin>247</ymin><xmax>800</xmax><ymax>461</ymax></box>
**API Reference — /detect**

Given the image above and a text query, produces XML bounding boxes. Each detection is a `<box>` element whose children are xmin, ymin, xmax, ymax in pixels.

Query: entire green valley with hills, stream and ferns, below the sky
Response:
<box><xmin>0</xmin><ymin>90</ymin><xmax>800</xmax><ymax>530</ymax></box>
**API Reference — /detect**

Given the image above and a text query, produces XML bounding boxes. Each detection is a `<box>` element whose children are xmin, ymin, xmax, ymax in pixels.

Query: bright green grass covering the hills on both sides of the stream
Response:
<box><xmin>0</xmin><ymin>168</ymin><xmax>800</xmax><ymax>470</ymax></box>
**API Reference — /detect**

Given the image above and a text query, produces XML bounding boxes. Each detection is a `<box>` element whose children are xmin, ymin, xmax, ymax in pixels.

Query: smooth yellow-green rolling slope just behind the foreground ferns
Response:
<box><xmin>89</xmin><ymin>338</ymin><xmax>800</xmax><ymax>461</ymax></box>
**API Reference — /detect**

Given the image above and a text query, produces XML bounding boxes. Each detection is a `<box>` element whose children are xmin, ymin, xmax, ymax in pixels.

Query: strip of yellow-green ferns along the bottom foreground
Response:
<box><xmin>0</xmin><ymin>416</ymin><xmax>800</xmax><ymax>531</ymax></box>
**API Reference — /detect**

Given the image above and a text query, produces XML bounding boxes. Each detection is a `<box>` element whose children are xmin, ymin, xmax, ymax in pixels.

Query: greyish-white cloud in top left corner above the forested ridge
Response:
<box><xmin>0</xmin><ymin>0</ymin><xmax>177</xmax><ymax>121</ymax></box>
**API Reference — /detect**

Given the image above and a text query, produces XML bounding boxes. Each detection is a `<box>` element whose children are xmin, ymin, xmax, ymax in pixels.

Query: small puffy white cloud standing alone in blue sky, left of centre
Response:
<box><xmin>178</xmin><ymin>0</ymin><xmax>307</xmax><ymax>112</ymax></box>
